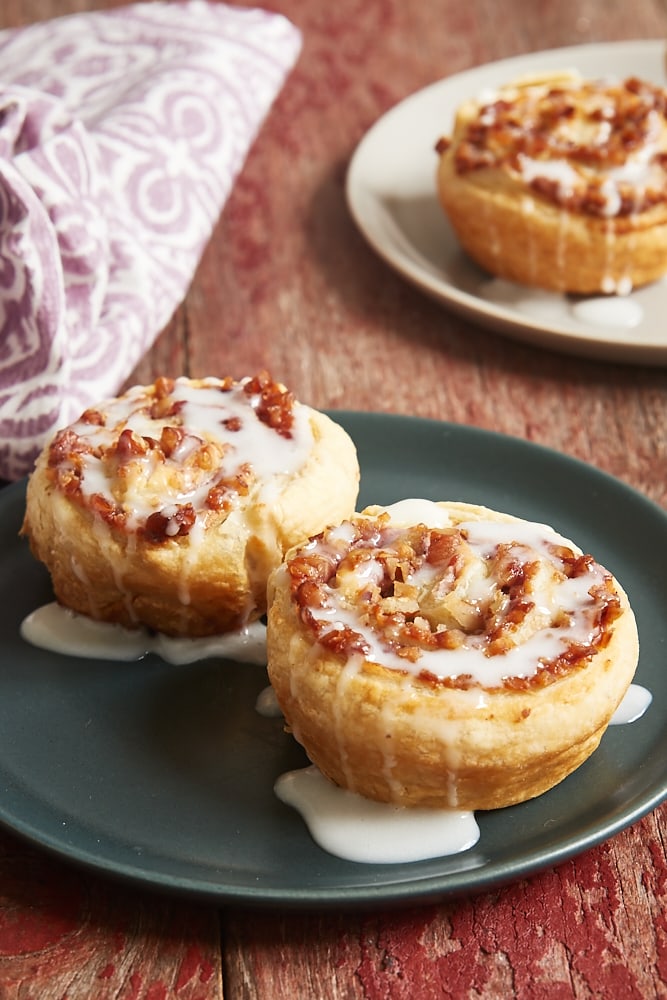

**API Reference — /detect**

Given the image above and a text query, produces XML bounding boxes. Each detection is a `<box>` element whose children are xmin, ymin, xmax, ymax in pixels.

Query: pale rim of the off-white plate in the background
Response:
<box><xmin>345</xmin><ymin>38</ymin><xmax>667</xmax><ymax>366</ymax></box>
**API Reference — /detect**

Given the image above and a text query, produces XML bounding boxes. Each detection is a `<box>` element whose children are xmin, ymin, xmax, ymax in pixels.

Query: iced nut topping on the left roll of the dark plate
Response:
<box><xmin>43</xmin><ymin>372</ymin><xmax>302</xmax><ymax>544</ymax></box>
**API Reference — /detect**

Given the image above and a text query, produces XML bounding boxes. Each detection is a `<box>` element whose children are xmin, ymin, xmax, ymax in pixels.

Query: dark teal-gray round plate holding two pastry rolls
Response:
<box><xmin>0</xmin><ymin>413</ymin><xmax>667</xmax><ymax>907</ymax></box>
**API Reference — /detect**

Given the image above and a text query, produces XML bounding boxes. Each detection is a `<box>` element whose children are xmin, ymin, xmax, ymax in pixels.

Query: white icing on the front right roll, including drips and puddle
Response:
<box><xmin>275</xmin><ymin>499</ymin><xmax>651</xmax><ymax>864</ymax></box>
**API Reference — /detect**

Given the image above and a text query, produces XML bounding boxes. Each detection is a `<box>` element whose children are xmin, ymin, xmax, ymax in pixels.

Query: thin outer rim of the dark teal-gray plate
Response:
<box><xmin>0</xmin><ymin>410</ymin><xmax>667</xmax><ymax>909</ymax></box>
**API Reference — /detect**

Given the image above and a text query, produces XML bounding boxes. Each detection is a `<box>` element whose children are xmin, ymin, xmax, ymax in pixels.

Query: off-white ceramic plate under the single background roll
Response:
<box><xmin>347</xmin><ymin>41</ymin><xmax>667</xmax><ymax>365</ymax></box>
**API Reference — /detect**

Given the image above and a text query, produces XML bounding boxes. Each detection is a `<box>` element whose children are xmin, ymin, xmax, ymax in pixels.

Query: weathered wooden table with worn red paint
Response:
<box><xmin>0</xmin><ymin>0</ymin><xmax>667</xmax><ymax>1000</ymax></box>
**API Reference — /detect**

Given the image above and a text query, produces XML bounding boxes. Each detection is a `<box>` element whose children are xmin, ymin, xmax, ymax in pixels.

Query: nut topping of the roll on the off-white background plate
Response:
<box><xmin>436</xmin><ymin>77</ymin><xmax>667</xmax><ymax>217</ymax></box>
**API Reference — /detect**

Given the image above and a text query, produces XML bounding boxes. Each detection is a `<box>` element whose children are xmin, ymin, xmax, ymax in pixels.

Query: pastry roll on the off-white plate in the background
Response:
<box><xmin>436</xmin><ymin>73</ymin><xmax>667</xmax><ymax>294</ymax></box>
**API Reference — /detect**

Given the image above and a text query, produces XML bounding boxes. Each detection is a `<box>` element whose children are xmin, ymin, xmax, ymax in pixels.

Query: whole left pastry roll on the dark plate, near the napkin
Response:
<box><xmin>22</xmin><ymin>373</ymin><xmax>359</xmax><ymax>637</ymax></box>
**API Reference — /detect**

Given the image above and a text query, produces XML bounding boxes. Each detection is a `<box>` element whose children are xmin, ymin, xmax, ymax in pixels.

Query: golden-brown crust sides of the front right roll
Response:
<box><xmin>267</xmin><ymin>504</ymin><xmax>638</xmax><ymax>809</ymax></box>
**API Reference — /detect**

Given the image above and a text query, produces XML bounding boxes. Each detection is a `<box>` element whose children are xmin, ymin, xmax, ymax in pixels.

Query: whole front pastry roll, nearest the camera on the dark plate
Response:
<box><xmin>267</xmin><ymin>501</ymin><xmax>638</xmax><ymax>810</ymax></box>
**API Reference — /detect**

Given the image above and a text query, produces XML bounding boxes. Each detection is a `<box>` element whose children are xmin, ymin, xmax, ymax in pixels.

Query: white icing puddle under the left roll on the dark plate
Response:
<box><xmin>21</xmin><ymin>601</ymin><xmax>266</xmax><ymax>664</ymax></box>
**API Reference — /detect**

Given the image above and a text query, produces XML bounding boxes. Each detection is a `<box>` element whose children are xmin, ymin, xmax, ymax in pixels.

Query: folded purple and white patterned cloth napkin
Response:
<box><xmin>0</xmin><ymin>0</ymin><xmax>301</xmax><ymax>479</ymax></box>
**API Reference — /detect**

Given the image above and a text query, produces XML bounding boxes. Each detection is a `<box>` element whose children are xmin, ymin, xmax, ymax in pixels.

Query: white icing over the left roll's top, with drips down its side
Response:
<box><xmin>46</xmin><ymin>378</ymin><xmax>313</xmax><ymax>624</ymax></box>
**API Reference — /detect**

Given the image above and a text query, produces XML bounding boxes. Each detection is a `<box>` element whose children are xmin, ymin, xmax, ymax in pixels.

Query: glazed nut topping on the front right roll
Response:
<box><xmin>286</xmin><ymin>514</ymin><xmax>621</xmax><ymax>689</ymax></box>
